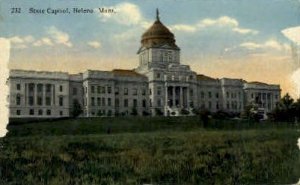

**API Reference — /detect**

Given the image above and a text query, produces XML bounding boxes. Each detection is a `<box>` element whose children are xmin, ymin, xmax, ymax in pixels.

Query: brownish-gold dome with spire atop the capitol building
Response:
<box><xmin>141</xmin><ymin>10</ymin><xmax>178</xmax><ymax>49</ymax></box>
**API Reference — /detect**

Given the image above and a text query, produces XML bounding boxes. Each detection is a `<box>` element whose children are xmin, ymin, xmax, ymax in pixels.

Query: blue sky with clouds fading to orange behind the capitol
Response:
<box><xmin>0</xmin><ymin>0</ymin><xmax>300</xmax><ymax>95</ymax></box>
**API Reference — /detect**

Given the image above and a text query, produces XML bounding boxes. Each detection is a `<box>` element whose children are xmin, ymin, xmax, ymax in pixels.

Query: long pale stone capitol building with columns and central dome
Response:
<box><xmin>7</xmin><ymin>12</ymin><xmax>281</xmax><ymax>118</ymax></box>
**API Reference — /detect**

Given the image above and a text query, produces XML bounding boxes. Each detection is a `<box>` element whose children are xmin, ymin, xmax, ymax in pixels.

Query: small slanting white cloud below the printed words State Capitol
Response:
<box><xmin>47</xmin><ymin>26</ymin><xmax>73</xmax><ymax>47</ymax></box>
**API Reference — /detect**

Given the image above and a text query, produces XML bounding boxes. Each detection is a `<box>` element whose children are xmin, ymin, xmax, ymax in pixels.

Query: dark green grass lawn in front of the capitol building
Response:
<box><xmin>0</xmin><ymin>117</ymin><xmax>300</xmax><ymax>185</ymax></box>
